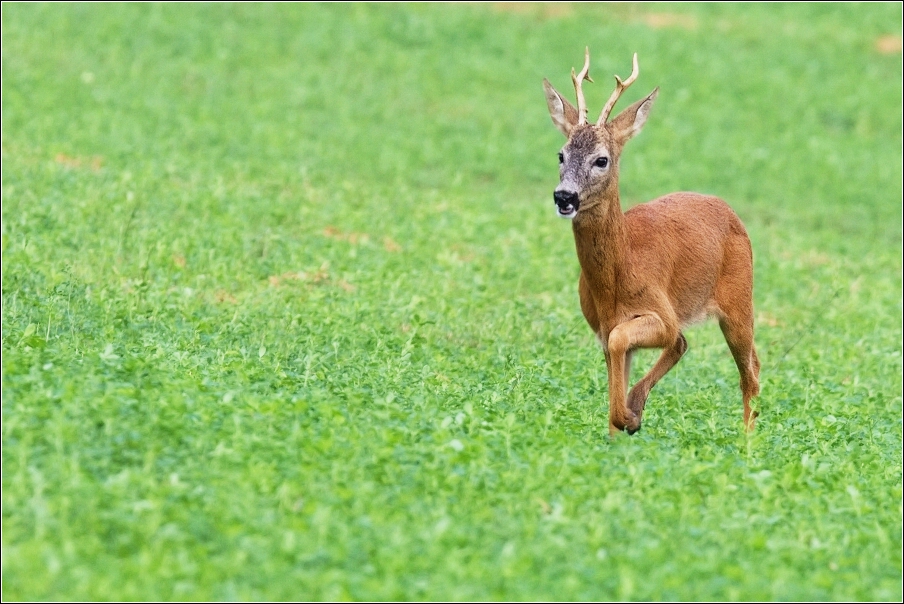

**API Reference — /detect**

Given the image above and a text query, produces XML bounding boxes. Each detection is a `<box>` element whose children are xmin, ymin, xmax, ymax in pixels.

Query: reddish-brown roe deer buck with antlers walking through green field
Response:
<box><xmin>543</xmin><ymin>49</ymin><xmax>760</xmax><ymax>436</ymax></box>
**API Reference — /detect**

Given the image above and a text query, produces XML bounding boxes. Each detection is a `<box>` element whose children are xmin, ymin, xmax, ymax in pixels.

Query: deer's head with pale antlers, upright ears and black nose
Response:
<box><xmin>543</xmin><ymin>48</ymin><xmax>659</xmax><ymax>218</ymax></box>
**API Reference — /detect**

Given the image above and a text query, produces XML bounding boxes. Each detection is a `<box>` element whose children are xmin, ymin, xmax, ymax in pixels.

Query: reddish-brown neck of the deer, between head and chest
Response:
<box><xmin>572</xmin><ymin>179</ymin><xmax>628</xmax><ymax>290</ymax></box>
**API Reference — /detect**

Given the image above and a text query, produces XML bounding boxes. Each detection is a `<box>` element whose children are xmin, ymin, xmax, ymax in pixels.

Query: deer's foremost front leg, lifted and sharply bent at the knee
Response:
<box><xmin>606</xmin><ymin>314</ymin><xmax>678</xmax><ymax>436</ymax></box>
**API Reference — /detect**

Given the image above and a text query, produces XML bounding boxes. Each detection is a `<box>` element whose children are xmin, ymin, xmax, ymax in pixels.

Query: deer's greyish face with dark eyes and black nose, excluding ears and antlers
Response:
<box><xmin>553</xmin><ymin>125</ymin><xmax>618</xmax><ymax>218</ymax></box>
